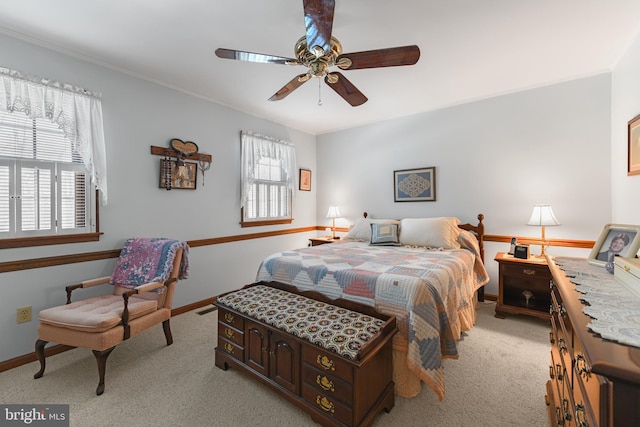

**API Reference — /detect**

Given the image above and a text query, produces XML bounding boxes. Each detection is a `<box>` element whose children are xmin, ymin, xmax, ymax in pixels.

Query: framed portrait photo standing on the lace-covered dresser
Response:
<box><xmin>589</xmin><ymin>224</ymin><xmax>640</xmax><ymax>266</ymax></box>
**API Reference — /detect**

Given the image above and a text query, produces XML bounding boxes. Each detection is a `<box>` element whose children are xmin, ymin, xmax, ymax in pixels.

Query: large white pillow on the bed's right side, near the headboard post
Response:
<box><xmin>400</xmin><ymin>217</ymin><xmax>461</xmax><ymax>249</ymax></box>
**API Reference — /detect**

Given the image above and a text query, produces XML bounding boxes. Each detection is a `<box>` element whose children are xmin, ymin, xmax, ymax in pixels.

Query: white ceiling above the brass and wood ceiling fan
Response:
<box><xmin>0</xmin><ymin>0</ymin><xmax>640</xmax><ymax>134</ymax></box>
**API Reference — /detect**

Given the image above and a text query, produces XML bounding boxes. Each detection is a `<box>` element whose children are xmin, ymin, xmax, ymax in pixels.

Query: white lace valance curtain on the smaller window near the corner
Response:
<box><xmin>240</xmin><ymin>131</ymin><xmax>296</xmax><ymax>208</ymax></box>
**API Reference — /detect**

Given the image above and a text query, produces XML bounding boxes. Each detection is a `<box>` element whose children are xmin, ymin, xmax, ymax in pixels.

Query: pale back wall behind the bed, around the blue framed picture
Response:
<box><xmin>317</xmin><ymin>74</ymin><xmax>611</xmax><ymax>294</ymax></box>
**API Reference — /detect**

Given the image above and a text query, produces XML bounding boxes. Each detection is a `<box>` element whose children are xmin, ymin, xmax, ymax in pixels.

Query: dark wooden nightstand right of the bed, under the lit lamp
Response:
<box><xmin>495</xmin><ymin>252</ymin><xmax>551</xmax><ymax>320</ymax></box>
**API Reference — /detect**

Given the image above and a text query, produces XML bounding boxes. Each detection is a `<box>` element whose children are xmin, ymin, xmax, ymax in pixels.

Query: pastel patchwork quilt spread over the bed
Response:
<box><xmin>257</xmin><ymin>240</ymin><xmax>489</xmax><ymax>399</ymax></box>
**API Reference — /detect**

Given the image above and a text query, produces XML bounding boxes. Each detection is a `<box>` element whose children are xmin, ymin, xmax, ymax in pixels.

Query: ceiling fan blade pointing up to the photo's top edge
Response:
<box><xmin>302</xmin><ymin>0</ymin><xmax>335</xmax><ymax>56</ymax></box>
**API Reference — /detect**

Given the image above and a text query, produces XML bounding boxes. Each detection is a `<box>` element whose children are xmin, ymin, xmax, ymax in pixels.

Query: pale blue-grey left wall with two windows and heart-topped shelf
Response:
<box><xmin>0</xmin><ymin>35</ymin><xmax>317</xmax><ymax>361</ymax></box>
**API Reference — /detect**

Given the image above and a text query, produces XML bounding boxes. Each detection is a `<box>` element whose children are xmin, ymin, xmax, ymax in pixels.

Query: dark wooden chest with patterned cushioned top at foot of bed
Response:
<box><xmin>215</xmin><ymin>282</ymin><xmax>397</xmax><ymax>426</ymax></box>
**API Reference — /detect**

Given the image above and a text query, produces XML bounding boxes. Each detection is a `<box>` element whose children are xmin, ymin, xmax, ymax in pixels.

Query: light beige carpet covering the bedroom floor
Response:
<box><xmin>0</xmin><ymin>302</ymin><xmax>550</xmax><ymax>427</ymax></box>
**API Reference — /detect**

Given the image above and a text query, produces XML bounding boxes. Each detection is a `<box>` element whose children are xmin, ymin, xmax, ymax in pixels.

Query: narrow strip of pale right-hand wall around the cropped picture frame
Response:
<box><xmin>611</xmin><ymin>30</ymin><xmax>640</xmax><ymax>224</ymax></box>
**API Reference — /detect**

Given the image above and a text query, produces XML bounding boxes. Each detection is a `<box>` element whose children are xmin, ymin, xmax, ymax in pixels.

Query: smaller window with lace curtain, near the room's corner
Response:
<box><xmin>241</xmin><ymin>132</ymin><xmax>296</xmax><ymax>227</ymax></box>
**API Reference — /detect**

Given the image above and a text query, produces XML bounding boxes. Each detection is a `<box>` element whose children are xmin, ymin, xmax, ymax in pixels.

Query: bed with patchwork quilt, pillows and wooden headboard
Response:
<box><xmin>257</xmin><ymin>214</ymin><xmax>489</xmax><ymax>400</ymax></box>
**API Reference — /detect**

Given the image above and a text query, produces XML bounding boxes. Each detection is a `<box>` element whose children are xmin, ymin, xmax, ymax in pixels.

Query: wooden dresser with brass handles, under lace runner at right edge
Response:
<box><xmin>546</xmin><ymin>256</ymin><xmax>640</xmax><ymax>427</ymax></box>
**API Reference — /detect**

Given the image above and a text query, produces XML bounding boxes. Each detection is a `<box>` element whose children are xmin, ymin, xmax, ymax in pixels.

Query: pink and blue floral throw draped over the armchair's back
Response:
<box><xmin>110</xmin><ymin>237</ymin><xmax>189</xmax><ymax>288</ymax></box>
